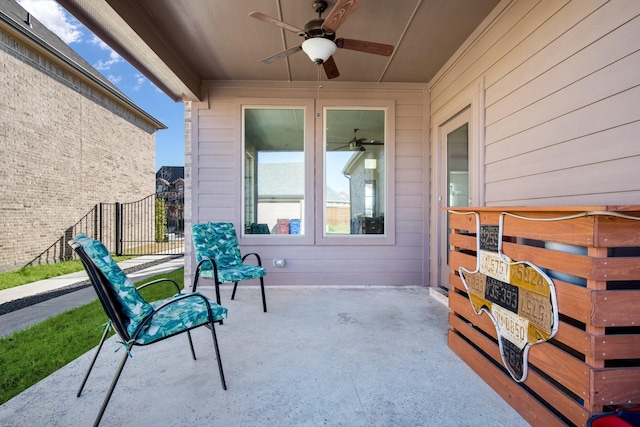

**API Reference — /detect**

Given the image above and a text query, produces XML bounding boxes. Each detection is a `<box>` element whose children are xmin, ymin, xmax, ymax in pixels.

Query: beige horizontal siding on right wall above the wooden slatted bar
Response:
<box><xmin>430</xmin><ymin>0</ymin><xmax>640</xmax><ymax>206</ymax></box>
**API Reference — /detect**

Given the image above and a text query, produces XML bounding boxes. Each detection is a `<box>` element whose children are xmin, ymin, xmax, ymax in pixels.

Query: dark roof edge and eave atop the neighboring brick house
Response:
<box><xmin>0</xmin><ymin>0</ymin><xmax>167</xmax><ymax>129</ymax></box>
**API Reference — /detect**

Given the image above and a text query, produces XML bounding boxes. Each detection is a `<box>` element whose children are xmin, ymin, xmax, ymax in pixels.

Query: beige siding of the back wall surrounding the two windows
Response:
<box><xmin>186</xmin><ymin>82</ymin><xmax>428</xmax><ymax>286</ymax></box>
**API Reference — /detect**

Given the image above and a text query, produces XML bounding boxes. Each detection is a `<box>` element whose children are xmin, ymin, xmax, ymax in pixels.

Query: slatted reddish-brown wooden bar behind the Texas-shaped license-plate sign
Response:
<box><xmin>448</xmin><ymin>206</ymin><xmax>640</xmax><ymax>426</ymax></box>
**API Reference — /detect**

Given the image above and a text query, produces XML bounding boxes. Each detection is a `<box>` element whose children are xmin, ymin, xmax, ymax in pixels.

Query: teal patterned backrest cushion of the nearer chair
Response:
<box><xmin>74</xmin><ymin>234</ymin><xmax>153</xmax><ymax>334</ymax></box>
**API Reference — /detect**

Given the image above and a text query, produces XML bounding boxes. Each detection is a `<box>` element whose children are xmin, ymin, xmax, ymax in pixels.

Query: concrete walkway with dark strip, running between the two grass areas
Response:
<box><xmin>0</xmin><ymin>255</ymin><xmax>184</xmax><ymax>337</ymax></box>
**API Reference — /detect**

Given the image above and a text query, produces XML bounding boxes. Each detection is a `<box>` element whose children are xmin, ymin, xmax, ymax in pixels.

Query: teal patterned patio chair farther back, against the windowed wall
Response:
<box><xmin>191</xmin><ymin>222</ymin><xmax>267</xmax><ymax>313</ymax></box>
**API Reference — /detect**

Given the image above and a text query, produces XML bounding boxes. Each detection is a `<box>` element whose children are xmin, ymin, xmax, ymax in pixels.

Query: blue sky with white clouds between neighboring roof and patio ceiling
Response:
<box><xmin>18</xmin><ymin>0</ymin><xmax>184</xmax><ymax>170</ymax></box>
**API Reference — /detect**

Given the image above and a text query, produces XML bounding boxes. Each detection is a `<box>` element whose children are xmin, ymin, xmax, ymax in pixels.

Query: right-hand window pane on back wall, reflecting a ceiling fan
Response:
<box><xmin>324</xmin><ymin>109</ymin><xmax>386</xmax><ymax>235</ymax></box>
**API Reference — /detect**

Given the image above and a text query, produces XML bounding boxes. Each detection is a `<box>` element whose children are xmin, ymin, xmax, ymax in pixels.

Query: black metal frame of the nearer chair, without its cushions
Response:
<box><xmin>69</xmin><ymin>240</ymin><xmax>227</xmax><ymax>426</ymax></box>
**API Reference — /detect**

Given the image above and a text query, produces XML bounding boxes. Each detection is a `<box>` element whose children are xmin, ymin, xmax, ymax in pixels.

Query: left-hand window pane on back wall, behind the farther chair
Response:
<box><xmin>243</xmin><ymin>107</ymin><xmax>306</xmax><ymax>235</ymax></box>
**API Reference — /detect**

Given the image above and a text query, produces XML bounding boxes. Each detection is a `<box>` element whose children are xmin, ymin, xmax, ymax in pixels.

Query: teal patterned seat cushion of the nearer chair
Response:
<box><xmin>135</xmin><ymin>292</ymin><xmax>227</xmax><ymax>345</ymax></box>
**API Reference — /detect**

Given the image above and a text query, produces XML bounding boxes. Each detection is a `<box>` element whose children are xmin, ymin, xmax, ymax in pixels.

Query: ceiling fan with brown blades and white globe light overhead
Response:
<box><xmin>249</xmin><ymin>0</ymin><xmax>394</xmax><ymax>79</ymax></box>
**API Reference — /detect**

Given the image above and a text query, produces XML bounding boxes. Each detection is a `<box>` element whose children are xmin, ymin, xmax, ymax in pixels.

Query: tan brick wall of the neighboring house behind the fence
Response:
<box><xmin>0</xmin><ymin>31</ymin><xmax>155</xmax><ymax>271</ymax></box>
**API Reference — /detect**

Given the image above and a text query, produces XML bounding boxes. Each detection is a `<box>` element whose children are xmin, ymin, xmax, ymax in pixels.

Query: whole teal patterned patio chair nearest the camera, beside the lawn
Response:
<box><xmin>69</xmin><ymin>234</ymin><xmax>227</xmax><ymax>426</ymax></box>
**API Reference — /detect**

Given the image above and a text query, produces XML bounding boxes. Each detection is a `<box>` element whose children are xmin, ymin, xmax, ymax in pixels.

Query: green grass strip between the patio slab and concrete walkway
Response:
<box><xmin>0</xmin><ymin>268</ymin><xmax>184</xmax><ymax>405</ymax></box>
